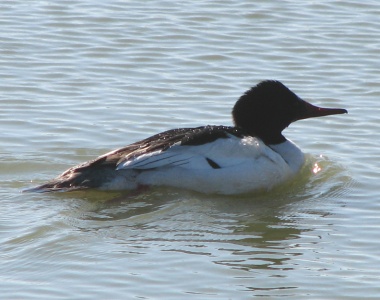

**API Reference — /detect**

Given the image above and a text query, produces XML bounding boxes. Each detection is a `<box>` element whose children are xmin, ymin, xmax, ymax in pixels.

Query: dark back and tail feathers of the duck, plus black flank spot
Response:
<box><xmin>29</xmin><ymin>126</ymin><xmax>244</xmax><ymax>192</ymax></box>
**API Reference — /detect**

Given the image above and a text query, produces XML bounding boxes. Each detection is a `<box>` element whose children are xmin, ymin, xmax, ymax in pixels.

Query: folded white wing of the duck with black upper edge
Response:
<box><xmin>117</xmin><ymin>126</ymin><xmax>244</xmax><ymax>170</ymax></box>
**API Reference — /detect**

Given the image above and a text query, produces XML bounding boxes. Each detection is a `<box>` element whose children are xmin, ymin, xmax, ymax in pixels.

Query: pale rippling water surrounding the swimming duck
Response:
<box><xmin>0</xmin><ymin>0</ymin><xmax>380</xmax><ymax>299</ymax></box>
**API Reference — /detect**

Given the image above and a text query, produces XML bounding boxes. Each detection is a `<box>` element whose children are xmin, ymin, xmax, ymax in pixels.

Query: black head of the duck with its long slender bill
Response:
<box><xmin>232</xmin><ymin>80</ymin><xmax>347</xmax><ymax>144</ymax></box>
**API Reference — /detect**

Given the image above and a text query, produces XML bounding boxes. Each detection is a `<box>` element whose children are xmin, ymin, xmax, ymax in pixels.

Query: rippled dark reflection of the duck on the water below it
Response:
<box><xmin>23</xmin><ymin>156</ymin><xmax>352</xmax><ymax>278</ymax></box>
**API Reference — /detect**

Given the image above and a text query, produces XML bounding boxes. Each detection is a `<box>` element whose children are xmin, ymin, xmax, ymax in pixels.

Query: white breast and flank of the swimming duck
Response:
<box><xmin>124</xmin><ymin>136</ymin><xmax>304</xmax><ymax>194</ymax></box>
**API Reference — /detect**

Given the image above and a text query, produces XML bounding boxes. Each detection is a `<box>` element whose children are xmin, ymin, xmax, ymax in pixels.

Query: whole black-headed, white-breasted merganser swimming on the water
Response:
<box><xmin>28</xmin><ymin>80</ymin><xmax>347</xmax><ymax>195</ymax></box>
